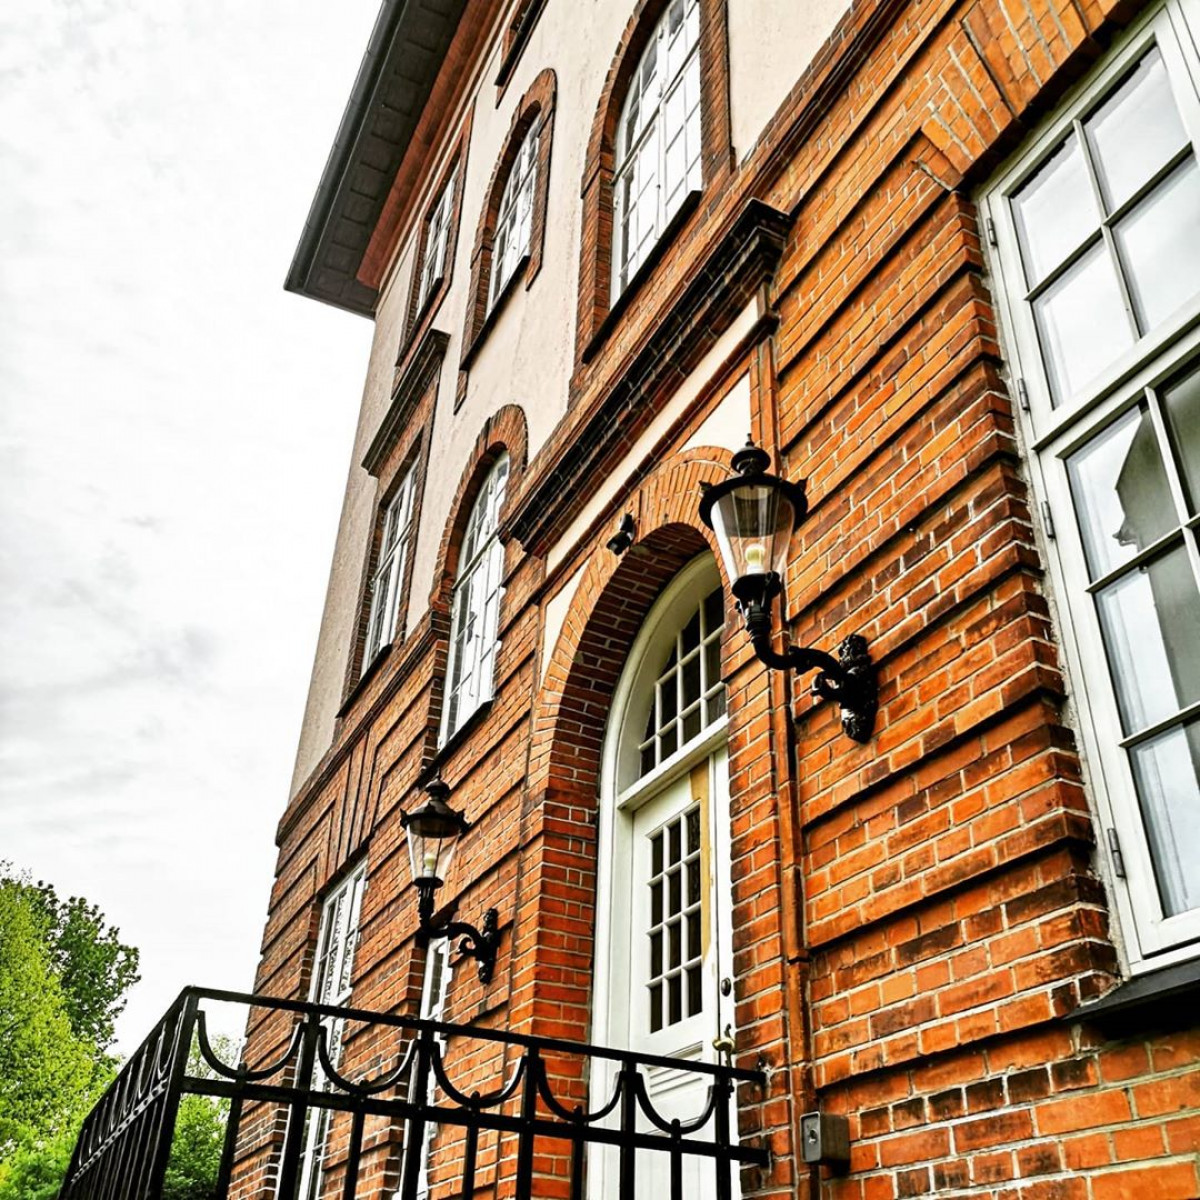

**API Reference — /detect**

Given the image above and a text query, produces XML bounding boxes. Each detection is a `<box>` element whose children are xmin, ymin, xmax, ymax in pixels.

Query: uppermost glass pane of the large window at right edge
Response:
<box><xmin>1084</xmin><ymin>49</ymin><xmax>1187</xmax><ymax>210</ymax></box>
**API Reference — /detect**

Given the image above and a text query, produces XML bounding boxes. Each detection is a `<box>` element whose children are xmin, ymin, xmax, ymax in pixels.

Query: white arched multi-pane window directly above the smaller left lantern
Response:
<box><xmin>442</xmin><ymin>455</ymin><xmax>509</xmax><ymax>744</ymax></box>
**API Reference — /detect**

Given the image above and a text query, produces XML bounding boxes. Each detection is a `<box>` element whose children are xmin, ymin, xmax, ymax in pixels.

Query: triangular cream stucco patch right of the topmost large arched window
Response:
<box><xmin>727</xmin><ymin>0</ymin><xmax>850</xmax><ymax>161</ymax></box>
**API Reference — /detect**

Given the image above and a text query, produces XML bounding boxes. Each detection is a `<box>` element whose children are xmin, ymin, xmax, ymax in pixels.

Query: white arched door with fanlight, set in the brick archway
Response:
<box><xmin>589</xmin><ymin>554</ymin><xmax>733</xmax><ymax>1200</ymax></box>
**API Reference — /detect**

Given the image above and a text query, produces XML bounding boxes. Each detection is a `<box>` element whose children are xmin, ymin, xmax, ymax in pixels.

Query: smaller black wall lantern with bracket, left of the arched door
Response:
<box><xmin>400</xmin><ymin>779</ymin><xmax>500</xmax><ymax>983</ymax></box>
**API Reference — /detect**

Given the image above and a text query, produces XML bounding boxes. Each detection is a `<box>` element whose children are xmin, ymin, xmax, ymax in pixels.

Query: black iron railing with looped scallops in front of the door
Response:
<box><xmin>60</xmin><ymin>988</ymin><xmax>767</xmax><ymax>1200</ymax></box>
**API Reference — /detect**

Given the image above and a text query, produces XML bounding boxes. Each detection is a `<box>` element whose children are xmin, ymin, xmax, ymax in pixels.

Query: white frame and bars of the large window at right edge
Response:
<box><xmin>980</xmin><ymin>0</ymin><xmax>1200</xmax><ymax>972</ymax></box>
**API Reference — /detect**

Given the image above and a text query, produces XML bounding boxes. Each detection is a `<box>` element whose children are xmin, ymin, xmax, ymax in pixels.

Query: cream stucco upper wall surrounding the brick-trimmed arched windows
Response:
<box><xmin>293</xmin><ymin>0</ymin><xmax>845</xmax><ymax>792</ymax></box>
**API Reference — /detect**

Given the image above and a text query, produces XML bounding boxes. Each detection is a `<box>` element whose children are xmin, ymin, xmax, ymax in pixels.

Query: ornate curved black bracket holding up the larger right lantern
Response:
<box><xmin>738</xmin><ymin>581</ymin><xmax>878</xmax><ymax>742</ymax></box>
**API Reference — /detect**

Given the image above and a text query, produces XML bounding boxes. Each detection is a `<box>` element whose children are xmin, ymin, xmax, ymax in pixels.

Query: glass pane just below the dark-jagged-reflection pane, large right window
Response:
<box><xmin>1096</xmin><ymin>546</ymin><xmax>1200</xmax><ymax>733</ymax></box>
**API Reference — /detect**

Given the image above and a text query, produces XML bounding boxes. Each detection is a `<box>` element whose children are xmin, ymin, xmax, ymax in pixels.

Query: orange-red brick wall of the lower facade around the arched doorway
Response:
<box><xmin>238</xmin><ymin>0</ymin><xmax>1200</xmax><ymax>1200</ymax></box>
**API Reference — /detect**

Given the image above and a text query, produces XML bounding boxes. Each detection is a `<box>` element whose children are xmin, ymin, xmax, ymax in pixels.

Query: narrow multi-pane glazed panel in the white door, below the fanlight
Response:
<box><xmin>646</xmin><ymin>804</ymin><xmax>704</xmax><ymax>1033</ymax></box>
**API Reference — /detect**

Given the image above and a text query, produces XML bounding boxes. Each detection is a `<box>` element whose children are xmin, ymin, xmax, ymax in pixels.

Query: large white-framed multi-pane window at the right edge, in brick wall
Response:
<box><xmin>985</xmin><ymin>2</ymin><xmax>1200</xmax><ymax>964</ymax></box>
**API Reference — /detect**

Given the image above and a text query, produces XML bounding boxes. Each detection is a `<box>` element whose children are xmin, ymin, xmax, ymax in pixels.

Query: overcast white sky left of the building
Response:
<box><xmin>0</xmin><ymin>0</ymin><xmax>379</xmax><ymax>1050</ymax></box>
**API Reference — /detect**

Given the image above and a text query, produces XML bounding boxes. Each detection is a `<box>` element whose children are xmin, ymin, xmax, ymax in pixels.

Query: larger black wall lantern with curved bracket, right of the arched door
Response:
<box><xmin>700</xmin><ymin>442</ymin><xmax>878</xmax><ymax>742</ymax></box>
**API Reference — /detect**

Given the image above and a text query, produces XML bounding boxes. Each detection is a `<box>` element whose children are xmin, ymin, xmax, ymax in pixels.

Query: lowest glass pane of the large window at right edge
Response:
<box><xmin>1133</xmin><ymin>721</ymin><xmax>1200</xmax><ymax>916</ymax></box>
